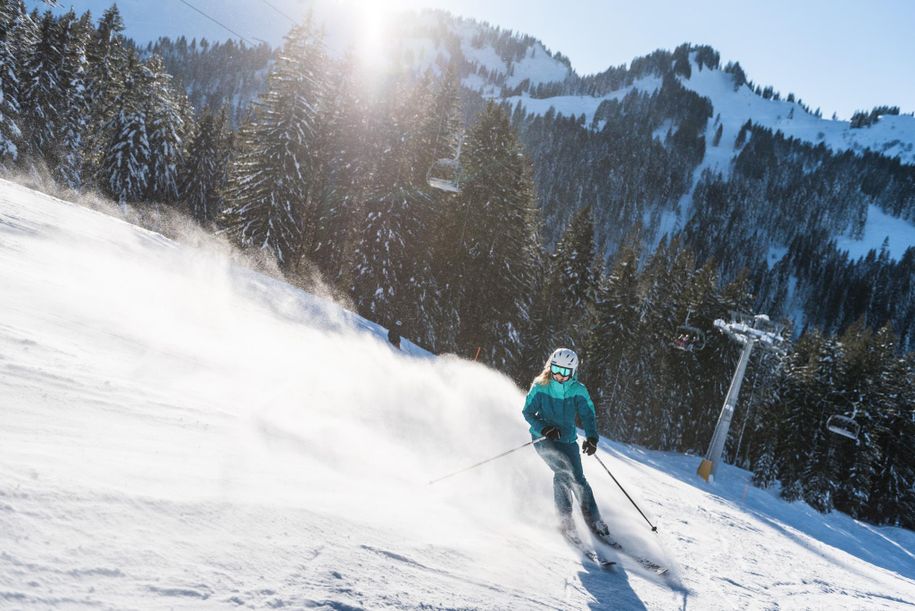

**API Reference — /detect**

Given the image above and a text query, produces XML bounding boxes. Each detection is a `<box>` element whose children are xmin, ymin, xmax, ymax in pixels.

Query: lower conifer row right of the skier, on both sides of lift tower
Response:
<box><xmin>526</xmin><ymin>200</ymin><xmax>915</xmax><ymax>528</ymax></box>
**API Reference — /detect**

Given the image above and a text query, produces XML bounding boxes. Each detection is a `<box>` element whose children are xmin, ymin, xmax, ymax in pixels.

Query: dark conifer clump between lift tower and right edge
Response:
<box><xmin>748</xmin><ymin>323</ymin><xmax>915</xmax><ymax>528</ymax></box>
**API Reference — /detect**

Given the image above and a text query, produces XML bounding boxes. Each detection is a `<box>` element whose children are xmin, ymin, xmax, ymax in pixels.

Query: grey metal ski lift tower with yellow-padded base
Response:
<box><xmin>696</xmin><ymin>312</ymin><xmax>785</xmax><ymax>482</ymax></box>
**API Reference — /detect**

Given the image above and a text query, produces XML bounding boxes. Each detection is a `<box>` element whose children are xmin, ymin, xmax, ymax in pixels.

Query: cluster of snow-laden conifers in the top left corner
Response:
<box><xmin>0</xmin><ymin>1</ymin><xmax>194</xmax><ymax>202</ymax></box>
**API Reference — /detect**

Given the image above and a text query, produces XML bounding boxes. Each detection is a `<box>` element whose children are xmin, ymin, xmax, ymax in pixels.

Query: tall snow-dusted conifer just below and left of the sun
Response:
<box><xmin>223</xmin><ymin>23</ymin><xmax>325</xmax><ymax>269</ymax></box>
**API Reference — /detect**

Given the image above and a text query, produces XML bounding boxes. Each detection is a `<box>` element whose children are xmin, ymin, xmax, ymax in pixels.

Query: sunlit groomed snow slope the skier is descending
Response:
<box><xmin>0</xmin><ymin>176</ymin><xmax>915</xmax><ymax>610</ymax></box>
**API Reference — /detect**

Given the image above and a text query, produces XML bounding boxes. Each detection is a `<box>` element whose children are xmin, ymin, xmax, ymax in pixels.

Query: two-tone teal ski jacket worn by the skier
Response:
<box><xmin>521</xmin><ymin>378</ymin><xmax>597</xmax><ymax>443</ymax></box>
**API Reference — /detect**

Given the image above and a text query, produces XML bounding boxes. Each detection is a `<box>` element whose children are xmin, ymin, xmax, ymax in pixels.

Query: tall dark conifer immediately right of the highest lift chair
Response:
<box><xmin>446</xmin><ymin>103</ymin><xmax>538</xmax><ymax>378</ymax></box>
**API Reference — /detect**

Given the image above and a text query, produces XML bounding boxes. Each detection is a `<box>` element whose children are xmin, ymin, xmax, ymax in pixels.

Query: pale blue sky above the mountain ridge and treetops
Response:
<box><xmin>26</xmin><ymin>0</ymin><xmax>915</xmax><ymax>119</ymax></box>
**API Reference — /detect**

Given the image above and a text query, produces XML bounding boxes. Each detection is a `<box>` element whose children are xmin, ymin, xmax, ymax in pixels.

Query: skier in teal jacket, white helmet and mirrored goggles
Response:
<box><xmin>522</xmin><ymin>348</ymin><xmax>609</xmax><ymax>536</ymax></box>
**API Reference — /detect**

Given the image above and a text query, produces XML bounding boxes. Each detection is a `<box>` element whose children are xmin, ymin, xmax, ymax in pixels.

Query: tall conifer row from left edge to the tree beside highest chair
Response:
<box><xmin>0</xmin><ymin>2</ymin><xmax>540</xmax><ymax>372</ymax></box>
